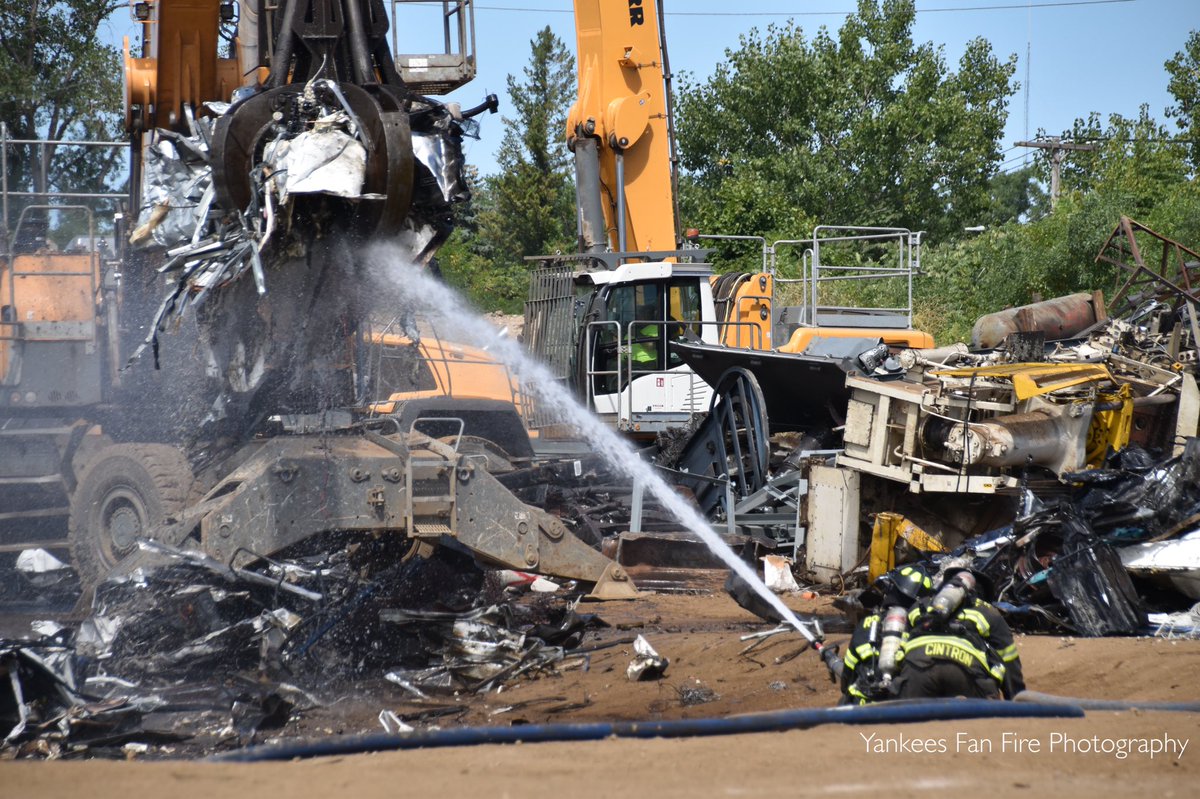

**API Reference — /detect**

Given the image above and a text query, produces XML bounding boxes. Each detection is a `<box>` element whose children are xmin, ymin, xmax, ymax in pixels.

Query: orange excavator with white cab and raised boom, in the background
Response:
<box><xmin>524</xmin><ymin>0</ymin><xmax>932</xmax><ymax>437</ymax></box>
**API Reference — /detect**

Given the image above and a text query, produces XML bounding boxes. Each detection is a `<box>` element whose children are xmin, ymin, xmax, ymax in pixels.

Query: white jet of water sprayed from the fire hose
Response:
<box><xmin>365</xmin><ymin>245</ymin><xmax>810</xmax><ymax>637</ymax></box>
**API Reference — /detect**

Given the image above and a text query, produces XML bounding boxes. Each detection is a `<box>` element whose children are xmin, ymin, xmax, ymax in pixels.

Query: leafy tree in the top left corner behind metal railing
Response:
<box><xmin>0</xmin><ymin>0</ymin><xmax>125</xmax><ymax>230</ymax></box>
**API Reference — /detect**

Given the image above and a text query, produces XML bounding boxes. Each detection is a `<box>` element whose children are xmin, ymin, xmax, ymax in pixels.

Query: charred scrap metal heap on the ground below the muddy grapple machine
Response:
<box><xmin>0</xmin><ymin>542</ymin><xmax>604</xmax><ymax>757</ymax></box>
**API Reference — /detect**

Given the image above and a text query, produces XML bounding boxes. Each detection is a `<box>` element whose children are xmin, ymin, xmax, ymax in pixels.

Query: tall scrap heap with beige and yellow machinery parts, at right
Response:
<box><xmin>657</xmin><ymin>218</ymin><xmax>1200</xmax><ymax>636</ymax></box>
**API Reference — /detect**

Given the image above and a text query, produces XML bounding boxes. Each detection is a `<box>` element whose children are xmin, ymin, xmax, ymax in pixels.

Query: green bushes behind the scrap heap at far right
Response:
<box><xmin>916</xmin><ymin>108</ymin><xmax>1200</xmax><ymax>342</ymax></box>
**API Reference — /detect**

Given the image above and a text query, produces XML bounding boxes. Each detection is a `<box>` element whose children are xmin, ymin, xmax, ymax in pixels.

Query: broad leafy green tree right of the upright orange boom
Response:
<box><xmin>677</xmin><ymin>0</ymin><xmax>1016</xmax><ymax>250</ymax></box>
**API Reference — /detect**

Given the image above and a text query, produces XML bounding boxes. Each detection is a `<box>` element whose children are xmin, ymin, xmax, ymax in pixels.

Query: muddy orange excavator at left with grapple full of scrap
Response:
<box><xmin>0</xmin><ymin>0</ymin><xmax>634</xmax><ymax>596</ymax></box>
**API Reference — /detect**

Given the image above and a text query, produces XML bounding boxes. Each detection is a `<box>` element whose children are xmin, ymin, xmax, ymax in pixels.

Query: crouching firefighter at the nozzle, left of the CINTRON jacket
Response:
<box><xmin>833</xmin><ymin>564</ymin><xmax>934</xmax><ymax>704</ymax></box>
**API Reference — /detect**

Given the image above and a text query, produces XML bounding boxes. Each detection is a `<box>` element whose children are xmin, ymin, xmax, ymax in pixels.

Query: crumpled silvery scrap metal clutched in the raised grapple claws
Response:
<box><xmin>130</xmin><ymin>78</ymin><xmax>469</xmax><ymax>354</ymax></box>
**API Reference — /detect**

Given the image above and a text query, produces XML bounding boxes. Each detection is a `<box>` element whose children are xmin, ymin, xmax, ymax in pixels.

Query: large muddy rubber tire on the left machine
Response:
<box><xmin>67</xmin><ymin>444</ymin><xmax>192</xmax><ymax>594</ymax></box>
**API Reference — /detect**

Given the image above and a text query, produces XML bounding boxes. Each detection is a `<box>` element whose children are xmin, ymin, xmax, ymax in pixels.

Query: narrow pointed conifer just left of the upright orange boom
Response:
<box><xmin>478</xmin><ymin>26</ymin><xmax>575</xmax><ymax>270</ymax></box>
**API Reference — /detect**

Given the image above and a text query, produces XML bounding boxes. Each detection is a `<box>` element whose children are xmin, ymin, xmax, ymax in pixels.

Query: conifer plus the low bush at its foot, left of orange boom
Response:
<box><xmin>448</xmin><ymin>26</ymin><xmax>575</xmax><ymax>312</ymax></box>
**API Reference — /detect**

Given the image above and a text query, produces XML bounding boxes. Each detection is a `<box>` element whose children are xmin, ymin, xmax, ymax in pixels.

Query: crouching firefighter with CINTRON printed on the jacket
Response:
<box><xmin>896</xmin><ymin>569</ymin><xmax>1025</xmax><ymax>699</ymax></box>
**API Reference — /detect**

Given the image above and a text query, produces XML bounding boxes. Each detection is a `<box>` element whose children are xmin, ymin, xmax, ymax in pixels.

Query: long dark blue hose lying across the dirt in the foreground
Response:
<box><xmin>209</xmin><ymin>699</ymin><xmax>1084</xmax><ymax>763</ymax></box>
